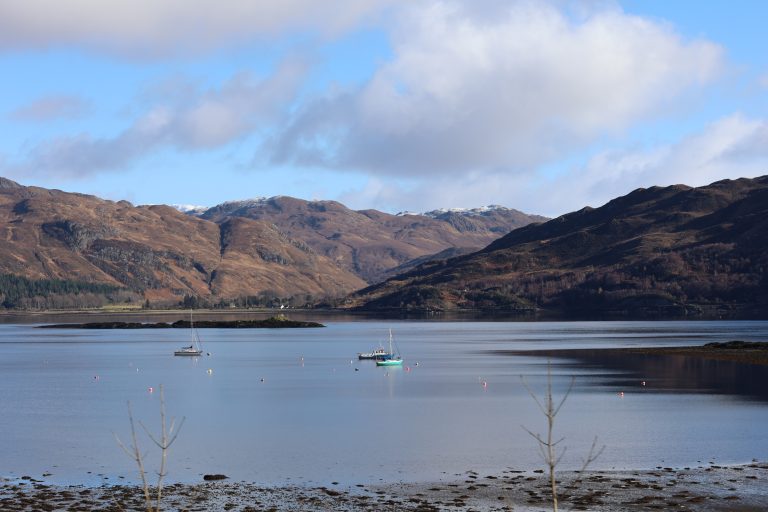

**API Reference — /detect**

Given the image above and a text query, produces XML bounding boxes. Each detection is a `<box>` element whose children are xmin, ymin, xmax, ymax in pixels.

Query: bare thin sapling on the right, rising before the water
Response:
<box><xmin>520</xmin><ymin>361</ymin><xmax>605</xmax><ymax>512</ymax></box>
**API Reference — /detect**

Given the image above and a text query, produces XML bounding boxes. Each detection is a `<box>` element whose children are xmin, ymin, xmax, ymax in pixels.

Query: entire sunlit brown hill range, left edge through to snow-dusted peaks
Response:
<box><xmin>0</xmin><ymin>178</ymin><xmax>538</xmax><ymax>308</ymax></box>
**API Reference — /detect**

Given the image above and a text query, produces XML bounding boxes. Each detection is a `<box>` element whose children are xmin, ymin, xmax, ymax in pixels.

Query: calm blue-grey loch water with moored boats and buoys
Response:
<box><xmin>0</xmin><ymin>321</ymin><xmax>768</xmax><ymax>484</ymax></box>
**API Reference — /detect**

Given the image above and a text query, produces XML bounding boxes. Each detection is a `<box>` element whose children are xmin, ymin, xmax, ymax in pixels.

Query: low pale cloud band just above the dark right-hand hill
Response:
<box><xmin>340</xmin><ymin>114</ymin><xmax>768</xmax><ymax>217</ymax></box>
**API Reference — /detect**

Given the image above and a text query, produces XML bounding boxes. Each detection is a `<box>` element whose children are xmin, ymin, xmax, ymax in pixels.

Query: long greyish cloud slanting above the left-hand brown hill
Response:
<box><xmin>6</xmin><ymin>61</ymin><xmax>306</xmax><ymax>177</ymax></box>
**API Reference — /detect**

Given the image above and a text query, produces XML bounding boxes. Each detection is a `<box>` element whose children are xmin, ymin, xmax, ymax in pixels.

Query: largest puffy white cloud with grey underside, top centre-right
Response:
<box><xmin>272</xmin><ymin>0</ymin><xmax>722</xmax><ymax>176</ymax></box>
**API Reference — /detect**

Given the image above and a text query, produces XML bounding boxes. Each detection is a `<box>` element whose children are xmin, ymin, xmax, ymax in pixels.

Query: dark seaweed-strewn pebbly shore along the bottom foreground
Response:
<box><xmin>0</xmin><ymin>461</ymin><xmax>768</xmax><ymax>512</ymax></box>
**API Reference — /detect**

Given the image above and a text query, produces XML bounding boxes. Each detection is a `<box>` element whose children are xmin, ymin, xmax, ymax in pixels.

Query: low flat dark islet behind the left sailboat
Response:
<box><xmin>39</xmin><ymin>315</ymin><xmax>325</xmax><ymax>329</ymax></box>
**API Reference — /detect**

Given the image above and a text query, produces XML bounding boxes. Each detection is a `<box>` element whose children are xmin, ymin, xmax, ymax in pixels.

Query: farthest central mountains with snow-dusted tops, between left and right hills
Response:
<box><xmin>196</xmin><ymin>196</ymin><xmax>547</xmax><ymax>283</ymax></box>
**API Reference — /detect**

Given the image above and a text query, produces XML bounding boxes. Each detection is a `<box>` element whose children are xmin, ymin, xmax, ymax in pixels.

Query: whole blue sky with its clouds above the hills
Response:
<box><xmin>0</xmin><ymin>0</ymin><xmax>768</xmax><ymax>216</ymax></box>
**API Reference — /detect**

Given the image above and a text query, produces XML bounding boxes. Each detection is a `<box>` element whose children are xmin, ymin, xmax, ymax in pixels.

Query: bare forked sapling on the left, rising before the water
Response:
<box><xmin>115</xmin><ymin>384</ymin><xmax>186</xmax><ymax>512</ymax></box>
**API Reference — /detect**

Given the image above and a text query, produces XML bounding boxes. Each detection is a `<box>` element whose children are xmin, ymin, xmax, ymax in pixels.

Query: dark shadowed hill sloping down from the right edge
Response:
<box><xmin>347</xmin><ymin>176</ymin><xmax>768</xmax><ymax>317</ymax></box>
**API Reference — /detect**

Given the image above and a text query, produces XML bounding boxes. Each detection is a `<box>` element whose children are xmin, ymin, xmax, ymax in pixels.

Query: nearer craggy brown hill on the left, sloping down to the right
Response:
<box><xmin>0</xmin><ymin>178</ymin><xmax>365</xmax><ymax>305</ymax></box>
